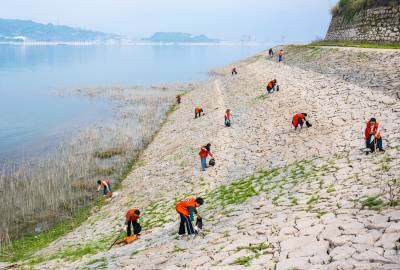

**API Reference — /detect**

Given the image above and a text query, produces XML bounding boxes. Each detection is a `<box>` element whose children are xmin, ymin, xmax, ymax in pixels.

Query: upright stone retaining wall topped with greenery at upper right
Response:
<box><xmin>325</xmin><ymin>6</ymin><xmax>400</xmax><ymax>43</ymax></box>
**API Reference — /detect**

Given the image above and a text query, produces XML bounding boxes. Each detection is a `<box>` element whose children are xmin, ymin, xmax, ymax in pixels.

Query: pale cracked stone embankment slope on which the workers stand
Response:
<box><xmin>7</xmin><ymin>47</ymin><xmax>400</xmax><ymax>270</ymax></box>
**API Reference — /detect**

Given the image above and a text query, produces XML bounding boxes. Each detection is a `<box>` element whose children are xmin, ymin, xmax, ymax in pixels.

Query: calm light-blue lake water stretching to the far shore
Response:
<box><xmin>0</xmin><ymin>45</ymin><xmax>267</xmax><ymax>161</ymax></box>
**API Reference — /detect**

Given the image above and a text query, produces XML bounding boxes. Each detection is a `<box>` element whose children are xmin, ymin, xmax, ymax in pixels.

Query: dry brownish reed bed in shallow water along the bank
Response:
<box><xmin>0</xmin><ymin>86</ymin><xmax>187</xmax><ymax>247</ymax></box>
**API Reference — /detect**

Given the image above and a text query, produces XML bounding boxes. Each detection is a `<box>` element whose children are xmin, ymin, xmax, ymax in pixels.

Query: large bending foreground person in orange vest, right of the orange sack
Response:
<box><xmin>175</xmin><ymin>197</ymin><xmax>204</xmax><ymax>235</ymax></box>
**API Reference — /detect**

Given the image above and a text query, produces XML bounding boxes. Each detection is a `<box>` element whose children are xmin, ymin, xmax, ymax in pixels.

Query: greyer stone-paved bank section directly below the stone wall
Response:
<box><xmin>286</xmin><ymin>46</ymin><xmax>400</xmax><ymax>99</ymax></box>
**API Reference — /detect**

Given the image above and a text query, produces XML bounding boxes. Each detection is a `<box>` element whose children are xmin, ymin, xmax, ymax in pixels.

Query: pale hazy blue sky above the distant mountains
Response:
<box><xmin>0</xmin><ymin>0</ymin><xmax>337</xmax><ymax>41</ymax></box>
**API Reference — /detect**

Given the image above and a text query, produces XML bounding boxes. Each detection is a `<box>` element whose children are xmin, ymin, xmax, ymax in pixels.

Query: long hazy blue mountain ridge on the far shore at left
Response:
<box><xmin>0</xmin><ymin>19</ymin><xmax>121</xmax><ymax>42</ymax></box>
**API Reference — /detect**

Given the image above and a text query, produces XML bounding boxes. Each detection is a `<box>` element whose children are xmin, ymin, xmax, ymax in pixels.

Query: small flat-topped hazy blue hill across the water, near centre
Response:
<box><xmin>143</xmin><ymin>32</ymin><xmax>219</xmax><ymax>43</ymax></box>
